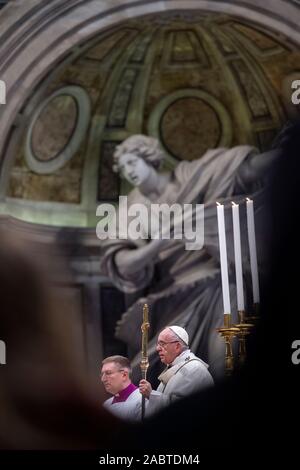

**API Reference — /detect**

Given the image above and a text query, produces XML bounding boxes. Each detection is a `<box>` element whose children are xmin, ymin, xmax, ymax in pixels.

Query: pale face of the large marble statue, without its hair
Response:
<box><xmin>118</xmin><ymin>153</ymin><xmax>151</xmax><ymax>186</ymax></box>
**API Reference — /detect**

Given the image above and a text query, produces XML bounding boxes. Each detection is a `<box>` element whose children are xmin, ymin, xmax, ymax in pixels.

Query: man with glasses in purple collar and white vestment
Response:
<box><xmin>101</xmin><ymin>356</ymin><xmax>141</xmax><ymax>421</ymax></box>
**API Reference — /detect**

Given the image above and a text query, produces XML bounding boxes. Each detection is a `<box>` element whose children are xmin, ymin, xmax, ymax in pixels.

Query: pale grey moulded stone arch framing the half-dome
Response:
<box><xmin>0</xmin><ymin>0</ymin><xmax>300</xmax><ymax>197</ymax></box>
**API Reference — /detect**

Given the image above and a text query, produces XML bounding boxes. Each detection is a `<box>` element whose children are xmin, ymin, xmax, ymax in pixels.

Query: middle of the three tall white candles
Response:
<box><xmin>232</xmin><ymin>202</ymin><xmax>245</xmax><ymax>311</ymax></box>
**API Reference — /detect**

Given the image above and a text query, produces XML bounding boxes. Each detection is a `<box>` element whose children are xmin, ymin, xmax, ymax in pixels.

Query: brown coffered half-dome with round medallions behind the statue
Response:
<box><xmin>7</xmin><ymin>12</ymin><xmax>300</xmax><ymax>227</ymax></box>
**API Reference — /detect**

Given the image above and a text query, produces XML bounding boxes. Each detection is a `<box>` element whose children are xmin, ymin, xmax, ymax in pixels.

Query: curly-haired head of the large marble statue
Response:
<box><xmin>113</xmin><ymin>135</ymin><xmax>164</xmax><ymax>186</ymax></box>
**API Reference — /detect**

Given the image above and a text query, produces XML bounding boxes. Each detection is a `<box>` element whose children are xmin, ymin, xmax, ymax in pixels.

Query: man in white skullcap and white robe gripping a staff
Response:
<box><xmin>139</xmin><ymin>325</ymin><xmax>214</xmax><ymax>415</ymax></box>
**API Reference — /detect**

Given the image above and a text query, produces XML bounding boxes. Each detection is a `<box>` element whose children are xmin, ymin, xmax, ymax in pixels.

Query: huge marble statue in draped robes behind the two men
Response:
<box><xmin>101</xmin><ymin>135</ymin><xmax>279</xmax><ymax>378</ymax></box>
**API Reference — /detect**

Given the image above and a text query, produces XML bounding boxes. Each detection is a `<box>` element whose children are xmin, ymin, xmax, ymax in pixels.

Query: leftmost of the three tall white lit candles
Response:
<box><xmin>217</xmin><ymin>202</ymin><xmax>231</xmax><ymax>314</ymax></box>
